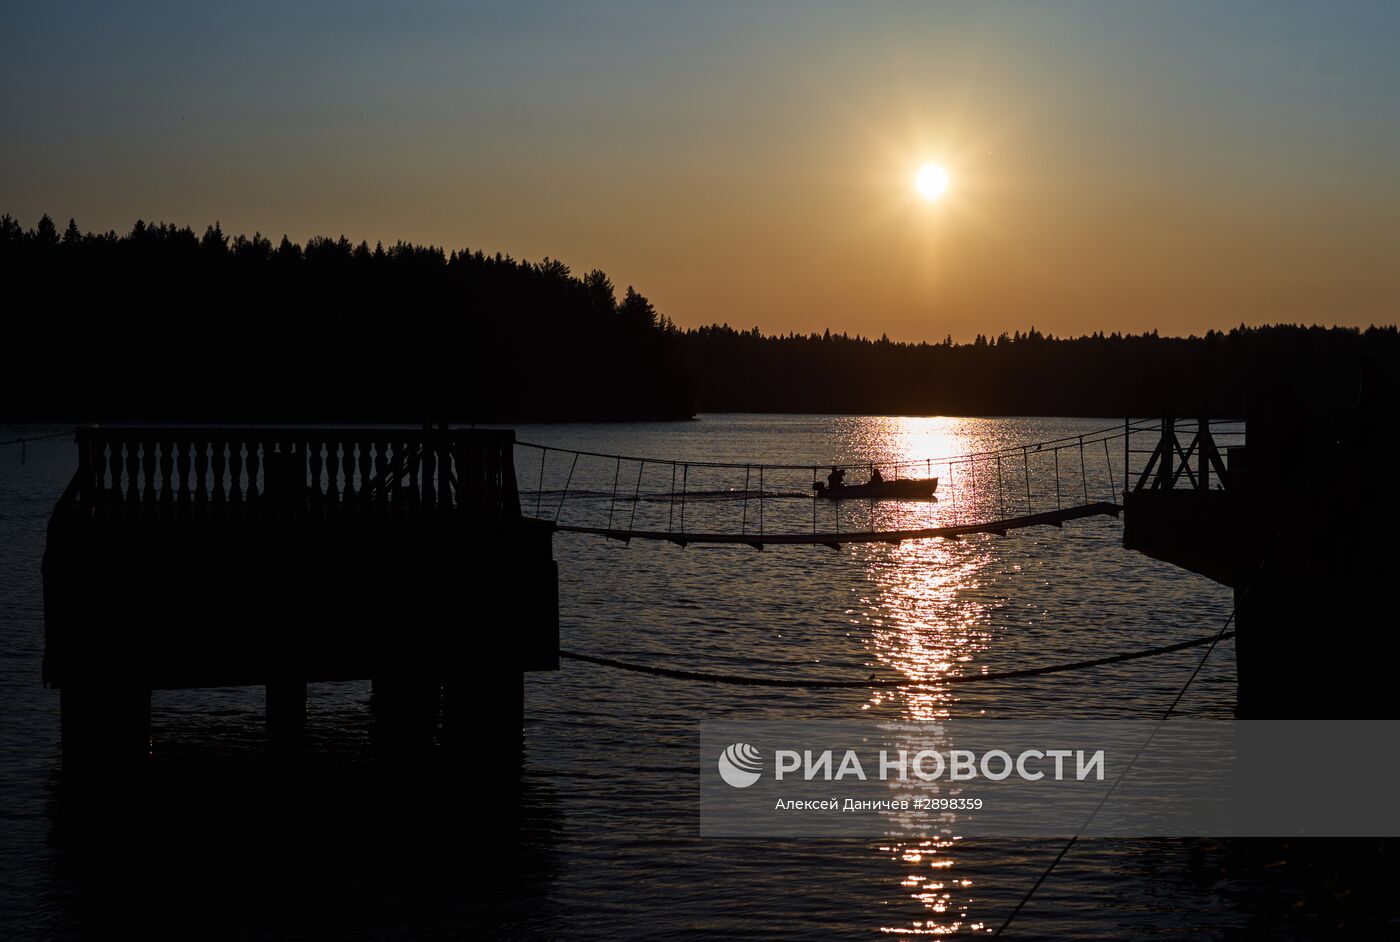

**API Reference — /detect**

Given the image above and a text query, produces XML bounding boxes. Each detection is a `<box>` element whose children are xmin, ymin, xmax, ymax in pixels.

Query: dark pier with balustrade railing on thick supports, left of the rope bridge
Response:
<box><xmin>43</xmin><ymin>428</ymin><xmax>559</xmax><ymax>768</ymax></box>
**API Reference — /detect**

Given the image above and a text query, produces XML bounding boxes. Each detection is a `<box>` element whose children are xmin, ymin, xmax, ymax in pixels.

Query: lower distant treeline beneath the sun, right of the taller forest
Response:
<box><xmin>683</xmin><ymin>325</ymin><xmax>1400</xmax><ymax>416</ymax></box>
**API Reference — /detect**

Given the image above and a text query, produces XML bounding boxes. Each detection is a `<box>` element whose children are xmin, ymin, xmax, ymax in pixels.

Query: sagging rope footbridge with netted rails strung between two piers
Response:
<box><xmin>515</xmin><ymin>420</ymin><xmax>1243</xmax><ymax>550</ymax></box>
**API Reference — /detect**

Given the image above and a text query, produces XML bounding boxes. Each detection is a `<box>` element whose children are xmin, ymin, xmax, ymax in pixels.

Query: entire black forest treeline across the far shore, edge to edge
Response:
<box><xmin>0</xmin><ymin>216</ymin><xmax>1400</xmax><ymax>423</ymax></box>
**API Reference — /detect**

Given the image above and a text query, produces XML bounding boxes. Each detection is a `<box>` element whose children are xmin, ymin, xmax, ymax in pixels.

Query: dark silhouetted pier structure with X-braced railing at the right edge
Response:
<box><xmin>1123</xmin><ymin>370</ymin><xmax>1400</xmax><ymax>719</ymax></box>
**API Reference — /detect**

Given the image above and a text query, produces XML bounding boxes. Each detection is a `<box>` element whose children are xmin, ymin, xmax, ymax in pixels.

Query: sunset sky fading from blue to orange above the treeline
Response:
<box><xmin>0</xmin><ymin>0</ymin><xmax>1400</xmax><ymax>340</ymax></box>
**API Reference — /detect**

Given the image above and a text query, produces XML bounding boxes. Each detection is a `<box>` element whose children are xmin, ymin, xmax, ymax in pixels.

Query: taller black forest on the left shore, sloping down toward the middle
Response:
<box><xmin>0</xmin><ymin>216</ymin><xmax>694</xmax><ymax>423</ymax></box>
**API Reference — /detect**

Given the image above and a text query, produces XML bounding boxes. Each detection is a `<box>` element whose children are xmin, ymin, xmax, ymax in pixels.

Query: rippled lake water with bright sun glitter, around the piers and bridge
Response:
<box><xmin>0</xmin><ymin>416</ymin><xmax>1344</xmax><ymax>939</ymax></box>
